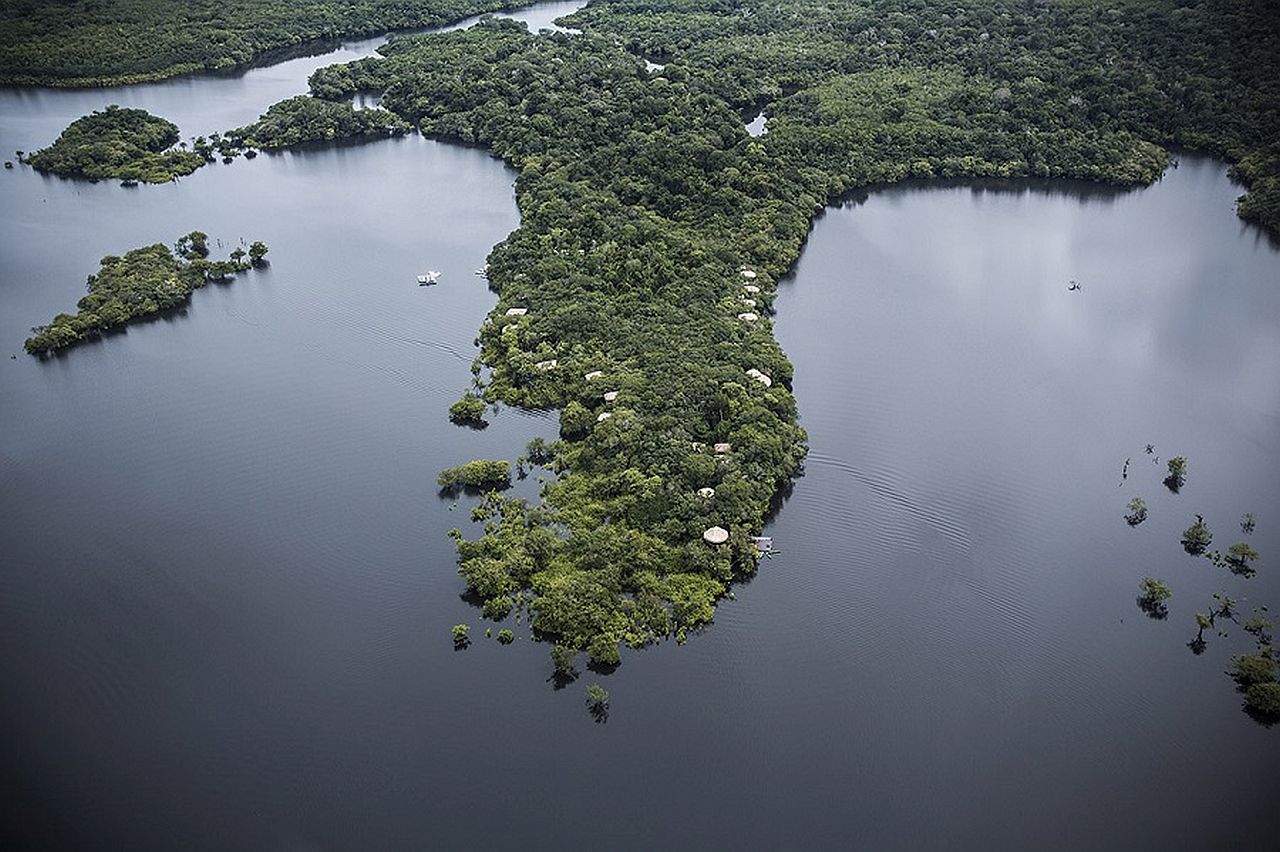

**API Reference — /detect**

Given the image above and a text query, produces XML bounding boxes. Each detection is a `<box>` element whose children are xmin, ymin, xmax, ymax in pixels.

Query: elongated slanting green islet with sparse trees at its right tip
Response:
<box><xmin>24</xmin><ymin>230</ymin><xmax>268</xmax><ymax>356</ymax></box>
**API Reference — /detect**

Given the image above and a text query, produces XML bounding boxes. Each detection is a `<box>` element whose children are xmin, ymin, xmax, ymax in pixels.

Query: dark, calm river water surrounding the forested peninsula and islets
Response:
<box><xmin>0</xmin><ymin>4</ymin><xmax>1280</xmax><ymax>849</ymax></box>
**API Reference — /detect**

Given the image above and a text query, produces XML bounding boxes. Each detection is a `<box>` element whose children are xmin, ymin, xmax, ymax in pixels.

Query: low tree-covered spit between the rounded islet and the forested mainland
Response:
<box><xmin>227</xmin><ymin>95</ymin><xmax>410</xmax><ymax>148</ymax></box>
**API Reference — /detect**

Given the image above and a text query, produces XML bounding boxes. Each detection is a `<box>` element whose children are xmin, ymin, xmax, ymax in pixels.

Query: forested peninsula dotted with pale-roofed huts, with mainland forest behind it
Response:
<box><xmin>262</xmin><ymin>0</ymin><xmax>1280</xmax><ymax>664</ymax></box>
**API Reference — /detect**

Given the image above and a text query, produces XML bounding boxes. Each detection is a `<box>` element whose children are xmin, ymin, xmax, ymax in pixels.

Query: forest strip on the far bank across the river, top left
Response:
<box><xmin>0</xmin><ymin>0</ymin><xmax>529</xmax><ymax>86</ymax></box>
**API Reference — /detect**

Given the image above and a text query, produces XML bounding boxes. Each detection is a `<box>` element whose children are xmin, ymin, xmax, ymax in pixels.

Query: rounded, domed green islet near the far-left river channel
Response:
<box><xmin>27</xmin><ymin>105</ymin><xmax>205</xmax><ymax>183</ymax></box>
